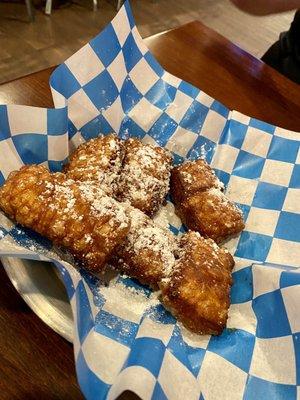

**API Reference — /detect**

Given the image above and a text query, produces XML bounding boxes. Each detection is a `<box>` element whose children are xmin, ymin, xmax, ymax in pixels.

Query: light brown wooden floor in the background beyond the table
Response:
<box><xmin>0</xmin><ymin>0</ymin><xmax>294</xmax><ymax>83</ymax></box>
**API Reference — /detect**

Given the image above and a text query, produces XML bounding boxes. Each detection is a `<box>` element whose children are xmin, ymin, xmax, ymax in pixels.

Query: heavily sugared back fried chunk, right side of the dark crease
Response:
<box><xmin>117</xmin><ymin>138</ymin><xmax>172</xmax><ymax>216</ymax></box>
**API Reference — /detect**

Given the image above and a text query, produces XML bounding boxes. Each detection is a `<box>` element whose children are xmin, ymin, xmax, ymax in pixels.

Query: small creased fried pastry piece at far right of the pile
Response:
<box><xmin>171</xmin><ymin>159</ymin><xmax>245</xmax><ymax>243</ymax></box>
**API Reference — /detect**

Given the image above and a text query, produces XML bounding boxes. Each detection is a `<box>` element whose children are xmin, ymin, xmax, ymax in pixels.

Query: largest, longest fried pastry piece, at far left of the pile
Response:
<box><xmin>0</xmin><ymin>165</ymin><xmax>129</xmax><ymax>272</ymax></box>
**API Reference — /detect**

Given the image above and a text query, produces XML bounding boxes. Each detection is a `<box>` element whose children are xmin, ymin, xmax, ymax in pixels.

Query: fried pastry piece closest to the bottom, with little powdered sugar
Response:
<box><xmin>160</xmin><ymin>232</ymin><xmax>234</xmax><ymax>335</ymax></box>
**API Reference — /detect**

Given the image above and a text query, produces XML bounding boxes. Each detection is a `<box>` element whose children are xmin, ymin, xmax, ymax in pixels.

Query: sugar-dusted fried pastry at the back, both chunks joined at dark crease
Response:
<box><xmin>64</xmin><ymin>134</ymin><xmax>172</xmax><ymax>215</ymax></box>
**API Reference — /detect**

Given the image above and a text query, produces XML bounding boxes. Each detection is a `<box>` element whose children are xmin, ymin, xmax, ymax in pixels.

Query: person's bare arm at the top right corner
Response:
<box><xmin>230</xmin><ymin>0</ymin><xmax>300</xmax><ymax>15</ymax></box>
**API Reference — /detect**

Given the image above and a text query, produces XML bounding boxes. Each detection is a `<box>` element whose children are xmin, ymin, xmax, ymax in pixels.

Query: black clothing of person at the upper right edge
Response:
<box><xmin>262</xmin><ymin>10</ymin><xmax>300</xmax><ymax>84</ymax></box>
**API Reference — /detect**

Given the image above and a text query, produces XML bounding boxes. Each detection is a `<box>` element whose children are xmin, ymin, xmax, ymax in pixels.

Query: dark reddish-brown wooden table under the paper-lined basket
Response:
<box><xmin>0</xmin><ymin>22</ymin><xmax>300</xmax><ymax>400</ymax></box>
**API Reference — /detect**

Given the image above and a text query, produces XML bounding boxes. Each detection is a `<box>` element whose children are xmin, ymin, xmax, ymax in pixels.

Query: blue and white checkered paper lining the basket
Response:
<box><xmin>0</xmin><ymin>2</ymin><xmax>300</xmax><ymax>400</ymax></box>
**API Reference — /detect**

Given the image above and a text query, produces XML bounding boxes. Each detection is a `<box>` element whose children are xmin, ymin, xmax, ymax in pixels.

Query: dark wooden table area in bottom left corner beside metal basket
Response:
<box><xmin>0</xmin><ymin>268</ymin><xmax>83</xmax><ymax>400</ymax></box>
